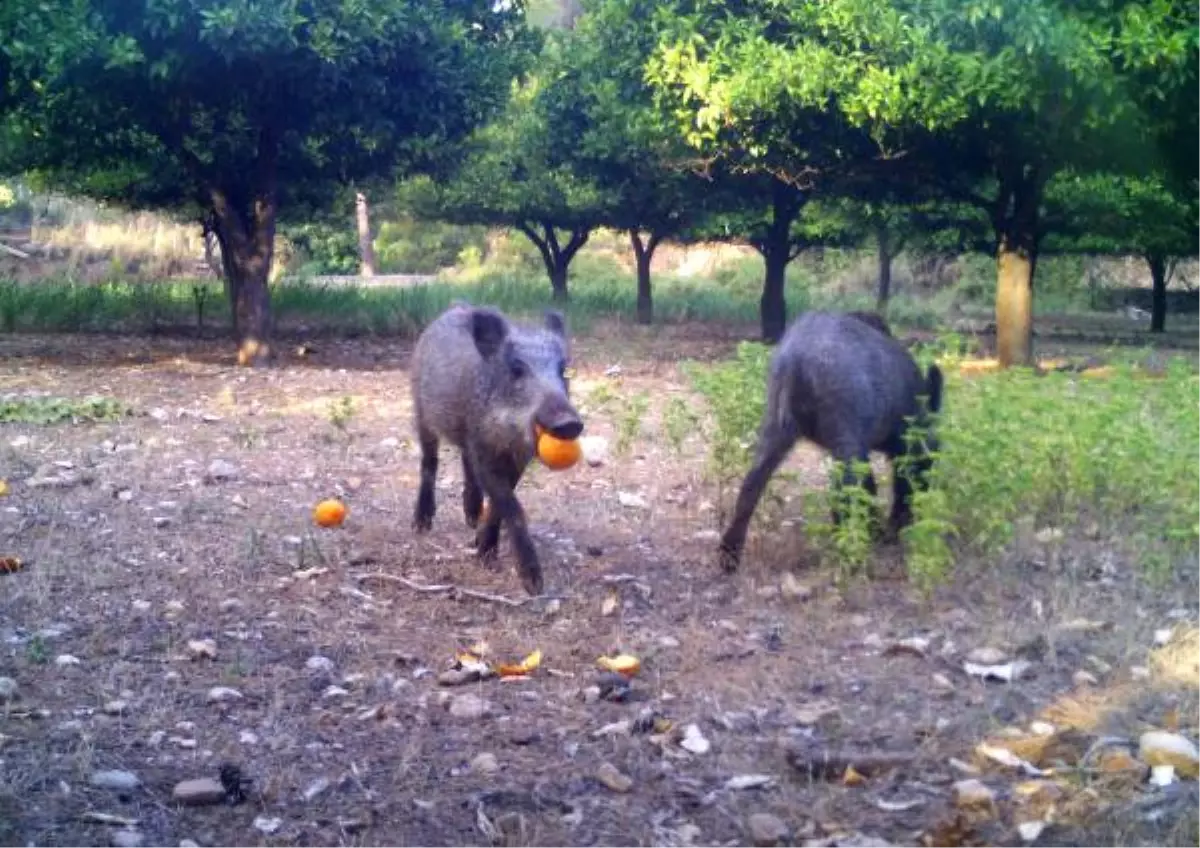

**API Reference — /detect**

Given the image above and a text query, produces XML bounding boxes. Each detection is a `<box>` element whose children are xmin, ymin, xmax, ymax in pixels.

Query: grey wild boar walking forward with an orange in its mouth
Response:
<box><xmin>412</xmin><ymin>301</ymin><xmax>583</xmax><ymax>595</ymax></box>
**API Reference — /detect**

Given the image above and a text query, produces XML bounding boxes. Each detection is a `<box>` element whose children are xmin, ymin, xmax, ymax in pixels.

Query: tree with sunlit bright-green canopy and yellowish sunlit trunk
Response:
<box><xmin>648</xmin><ymin>0</ymin><xmax>1198</xmax><ymax>365</ymax></box>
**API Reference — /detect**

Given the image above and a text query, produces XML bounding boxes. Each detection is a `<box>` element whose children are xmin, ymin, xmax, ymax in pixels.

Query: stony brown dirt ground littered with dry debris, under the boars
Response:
<box><xmin>0</xmin><ymin>329</ymin><xmax>1200</xmax><ymax>848</ymax></box>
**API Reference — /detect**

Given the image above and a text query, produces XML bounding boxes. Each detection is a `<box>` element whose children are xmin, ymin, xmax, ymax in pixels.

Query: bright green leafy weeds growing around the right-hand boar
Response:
<box><xmin>690</xmin><ymin>338</ymin><xmax>1200</xmax><ymax>588</ymax></box>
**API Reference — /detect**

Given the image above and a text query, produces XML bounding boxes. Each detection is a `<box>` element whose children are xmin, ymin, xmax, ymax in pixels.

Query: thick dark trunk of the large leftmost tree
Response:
<box><xmin>209</xmin><ymin>130</ymin><xmax>278</xmax><ymax>366</ymax></box>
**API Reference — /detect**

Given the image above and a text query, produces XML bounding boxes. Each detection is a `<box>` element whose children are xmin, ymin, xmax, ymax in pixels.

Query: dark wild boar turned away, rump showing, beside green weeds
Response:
<box><xmin>720</xmin><ymin>312</ymin><xmax>942</xmax><ymax>571</ymax></box>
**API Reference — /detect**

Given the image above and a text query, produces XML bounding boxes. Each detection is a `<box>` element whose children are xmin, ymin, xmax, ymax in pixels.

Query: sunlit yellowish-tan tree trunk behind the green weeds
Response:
<box><xmin>994</xmin><ymin>172</ymin><xmax>1043</xmax><ymax>368</ymax></box>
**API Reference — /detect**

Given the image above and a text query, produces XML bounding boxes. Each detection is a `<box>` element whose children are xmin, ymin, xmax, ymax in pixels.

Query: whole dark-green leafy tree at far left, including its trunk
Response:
<box><xmin>0</xmin><ymin>0</ymin><xmax>532</xmax><ymax>361</ymax></box>
